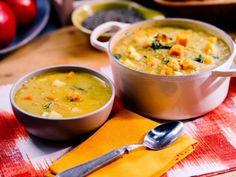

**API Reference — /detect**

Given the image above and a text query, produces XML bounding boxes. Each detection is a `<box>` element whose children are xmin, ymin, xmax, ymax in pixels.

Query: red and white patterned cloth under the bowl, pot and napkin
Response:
<box><xmin>0</xmin><ymin>67</ymin><xmax>236</xmax><ymax>177</ymax></box>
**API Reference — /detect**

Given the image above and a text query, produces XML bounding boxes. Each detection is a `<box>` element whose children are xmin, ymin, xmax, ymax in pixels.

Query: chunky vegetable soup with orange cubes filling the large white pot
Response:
<box><xmin>112</xmin><ymin>26</ymin><xmax>230</xmax><ymax>75</ymax></box>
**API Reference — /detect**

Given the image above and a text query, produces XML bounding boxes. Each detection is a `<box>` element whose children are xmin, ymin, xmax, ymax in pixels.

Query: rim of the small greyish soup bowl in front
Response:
<box><xmin>9</xmin><ymin>65</ymin><xmax>115</xmax><ymax>121</ymax></box>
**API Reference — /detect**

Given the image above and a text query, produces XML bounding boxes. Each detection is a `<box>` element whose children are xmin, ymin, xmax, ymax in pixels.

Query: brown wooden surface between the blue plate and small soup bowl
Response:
<box><xmin>0</xmin><ymin>27</ymin><xmax>109</xmax><ymax>85</ymax></box>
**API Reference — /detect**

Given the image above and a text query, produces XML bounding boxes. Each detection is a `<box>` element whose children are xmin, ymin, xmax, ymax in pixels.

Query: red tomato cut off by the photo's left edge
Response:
<box><xmin>0</xmin><ymin>1</ymin><xmax>16</xmax><ymax>49</ymax></box>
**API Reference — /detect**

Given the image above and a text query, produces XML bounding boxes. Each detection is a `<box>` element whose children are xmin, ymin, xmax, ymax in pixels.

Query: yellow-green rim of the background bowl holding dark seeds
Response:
<box><xmin>71</xmin><ymin>0</ymin><xmax>165</xmax><ymax>37</ymax></box>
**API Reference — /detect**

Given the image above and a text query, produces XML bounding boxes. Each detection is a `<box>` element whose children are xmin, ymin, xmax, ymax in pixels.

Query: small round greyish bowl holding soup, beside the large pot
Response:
<box><xmin>10</xmin><ymin>65</ymin><xmax>115</xmax><ymax>141</ymax></box>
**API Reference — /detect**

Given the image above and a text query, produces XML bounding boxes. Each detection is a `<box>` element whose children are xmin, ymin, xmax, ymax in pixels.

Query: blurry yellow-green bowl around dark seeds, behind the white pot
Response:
<box><xmin>72</xmin><ymin>1</ymin><xmax>165</xmax><ymax>37</ymax></box>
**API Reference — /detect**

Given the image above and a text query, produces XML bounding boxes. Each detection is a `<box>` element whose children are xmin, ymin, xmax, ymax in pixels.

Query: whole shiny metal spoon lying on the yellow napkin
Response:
<box><xmin>56</xmin><ymin>121</ymin><xmax>183</xmax><ymax>177</ymax></box>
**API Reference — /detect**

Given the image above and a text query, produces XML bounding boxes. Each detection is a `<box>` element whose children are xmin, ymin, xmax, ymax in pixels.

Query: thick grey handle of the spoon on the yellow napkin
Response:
<box><xmin>56</xmin><ymin>146</ymin><xmax>128</xmax><ymax>177</ymax></box>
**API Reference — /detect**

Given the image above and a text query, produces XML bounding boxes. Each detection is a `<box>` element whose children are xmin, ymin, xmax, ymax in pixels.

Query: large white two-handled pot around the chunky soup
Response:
<box><xmin>91</xmin><ymin>19</ymin><xmax>236</xmax><ymax>120</ymax></box>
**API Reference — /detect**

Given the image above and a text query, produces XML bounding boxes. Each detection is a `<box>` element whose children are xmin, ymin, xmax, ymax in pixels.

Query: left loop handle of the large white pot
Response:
<box><xmin>90</xmin><ymin>21</ymin><xmax>130</xmax><ymax>52</ymax></box>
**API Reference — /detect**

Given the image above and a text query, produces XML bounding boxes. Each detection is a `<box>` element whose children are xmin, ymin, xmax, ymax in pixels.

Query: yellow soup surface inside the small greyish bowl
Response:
<box><xmin>15</xmin><ymin>71</ymin><xmax>111</xmax><ymax>118</ymax></box>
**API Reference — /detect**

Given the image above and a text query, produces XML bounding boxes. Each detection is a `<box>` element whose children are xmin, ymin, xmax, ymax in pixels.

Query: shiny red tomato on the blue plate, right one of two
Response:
<box><xmin>6</xmin><ymin>0</ymin><xmax>37</xmax><ymax>28</ymax></box>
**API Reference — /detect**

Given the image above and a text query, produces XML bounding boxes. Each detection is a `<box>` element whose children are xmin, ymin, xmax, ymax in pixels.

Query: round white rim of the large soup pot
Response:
<box><xmin>106</xmin><ymin>18</ymin><xmax>236</xmax><ymax>80</ymax></box>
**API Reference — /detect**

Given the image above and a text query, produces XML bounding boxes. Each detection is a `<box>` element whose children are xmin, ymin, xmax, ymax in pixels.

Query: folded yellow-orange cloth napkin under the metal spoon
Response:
<box><xmin>45</xmin><ymin>110</ymin><xmax>197</xmax><ymax>177</ymax></box>
